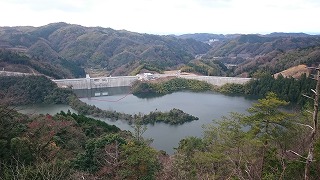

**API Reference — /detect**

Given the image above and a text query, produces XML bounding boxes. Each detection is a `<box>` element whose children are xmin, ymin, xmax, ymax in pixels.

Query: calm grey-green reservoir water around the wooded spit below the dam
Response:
<box><xmin>19</xmin><ymin>88</ymin><xmax>254</xmax><ymax>154</ymax></box>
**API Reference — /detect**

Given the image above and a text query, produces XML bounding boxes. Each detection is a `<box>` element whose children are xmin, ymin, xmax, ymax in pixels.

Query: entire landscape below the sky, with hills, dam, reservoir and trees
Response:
<box><xmin>0</xmin><ymin>22</ymin><xmax>320</xmax><ymax>180</ymax></box>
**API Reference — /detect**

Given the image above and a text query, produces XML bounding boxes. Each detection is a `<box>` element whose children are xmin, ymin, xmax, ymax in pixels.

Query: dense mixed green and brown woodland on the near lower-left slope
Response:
<box><xmin>0</xmin><ymin>105</ymin><xmax>160</xmax><ymax>180</ymax></box>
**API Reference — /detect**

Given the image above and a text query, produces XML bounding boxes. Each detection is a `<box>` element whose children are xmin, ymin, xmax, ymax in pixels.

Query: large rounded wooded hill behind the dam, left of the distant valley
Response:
<box><xmin>0</xmin><ymin>23</ymin><xmax>211</xmax><ymax>75</ymax></box>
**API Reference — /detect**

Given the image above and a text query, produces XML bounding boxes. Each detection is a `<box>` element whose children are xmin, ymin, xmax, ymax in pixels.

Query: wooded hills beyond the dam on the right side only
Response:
<box><xmin>202</xmin><ymin>34</ymin><xmax>320</xmax><ymax>77</ymax></box>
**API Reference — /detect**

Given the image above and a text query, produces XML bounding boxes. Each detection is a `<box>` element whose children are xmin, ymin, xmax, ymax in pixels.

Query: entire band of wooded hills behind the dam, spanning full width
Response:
<box><xmin>0</xmin><ymin>23</ymin><xmax>320</xmax><ymax>78</ymax></box>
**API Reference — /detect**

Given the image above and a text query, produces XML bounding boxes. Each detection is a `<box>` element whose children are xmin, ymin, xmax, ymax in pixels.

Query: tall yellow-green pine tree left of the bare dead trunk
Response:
<box><xmin>243</xmin><ymin>92</ymin><xmax>290</xmax><ymax>179</ymax></box>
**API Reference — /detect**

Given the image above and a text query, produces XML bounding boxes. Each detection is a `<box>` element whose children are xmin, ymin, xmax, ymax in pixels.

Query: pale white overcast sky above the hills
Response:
<box><xmin>0</xmin><ymin>0</ymin><xmax>320</xmax><ymax>34</ymax></box>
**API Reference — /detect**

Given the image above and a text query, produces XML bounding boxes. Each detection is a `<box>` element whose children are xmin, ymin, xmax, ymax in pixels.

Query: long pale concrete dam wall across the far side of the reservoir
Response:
<box><xmin>53</xmin><ymin>75</ymin><xmax>251</xmax><ymax>89</ymax></box>
